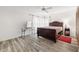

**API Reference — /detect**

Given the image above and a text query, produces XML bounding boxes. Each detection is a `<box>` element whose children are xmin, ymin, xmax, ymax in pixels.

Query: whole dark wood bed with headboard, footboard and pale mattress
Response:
<box><xmin>37</xmin><ymin>21</ymin><xmax>63</xmax><ymax>43</ymax></box>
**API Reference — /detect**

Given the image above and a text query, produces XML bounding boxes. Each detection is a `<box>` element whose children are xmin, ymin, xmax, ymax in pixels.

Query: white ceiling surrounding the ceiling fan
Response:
<box><xmin>0</xmin><ymin>6</ymin><xmax>75</xmax><ymax>15</ymax></box>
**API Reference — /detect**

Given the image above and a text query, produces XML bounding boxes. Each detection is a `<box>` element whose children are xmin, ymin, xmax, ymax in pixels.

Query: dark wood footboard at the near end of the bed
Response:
<box><xmin>37</xmin><ymin>28</ymin><xmax>56</xmax><ymax>43</ymax></box>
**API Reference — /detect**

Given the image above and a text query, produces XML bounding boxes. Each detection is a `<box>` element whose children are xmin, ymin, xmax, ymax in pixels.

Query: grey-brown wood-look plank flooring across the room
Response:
<box><xmin>0</xmin><ymin>35</ymin><xmax>78</xmax><ymax>52</ymax></box>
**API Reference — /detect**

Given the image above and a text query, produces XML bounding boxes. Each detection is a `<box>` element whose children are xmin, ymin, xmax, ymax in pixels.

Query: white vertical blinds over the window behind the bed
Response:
<box><xmin>33</xmin><ymin>16</ymin><xmax>49</xmax><ymax>32</ymax></box>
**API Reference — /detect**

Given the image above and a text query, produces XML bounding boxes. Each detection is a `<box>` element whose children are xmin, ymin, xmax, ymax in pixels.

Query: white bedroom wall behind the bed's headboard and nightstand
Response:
<box><xmin>50</xmin><ymin>7</ymin><xmax>76</xmax><ymax>37</ymax></box>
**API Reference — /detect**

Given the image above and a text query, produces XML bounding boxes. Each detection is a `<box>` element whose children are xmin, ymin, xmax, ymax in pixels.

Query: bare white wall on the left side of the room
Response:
<box><xmin>0</xmin><ymin>7</ymin><xmax>31</xmax><ymax>41</ymax></box>
